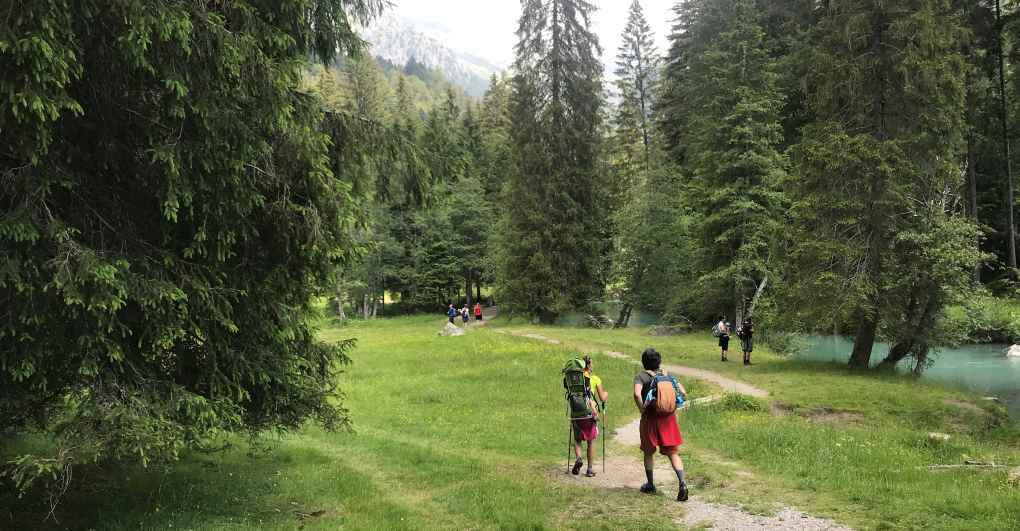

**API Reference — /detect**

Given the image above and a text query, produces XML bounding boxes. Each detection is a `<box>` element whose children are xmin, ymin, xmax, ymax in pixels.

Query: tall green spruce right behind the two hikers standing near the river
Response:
<box><xmin>665</xmin><ymin>0</ymin><xmax>786</xmax><ymax>319</ymax></box>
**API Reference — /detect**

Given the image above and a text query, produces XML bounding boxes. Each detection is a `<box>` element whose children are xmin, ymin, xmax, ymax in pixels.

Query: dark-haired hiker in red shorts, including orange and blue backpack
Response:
<box><xmin>634</xmin><ymin>349</ymin><xmax>687</xmax><ymax>501</ymax></box>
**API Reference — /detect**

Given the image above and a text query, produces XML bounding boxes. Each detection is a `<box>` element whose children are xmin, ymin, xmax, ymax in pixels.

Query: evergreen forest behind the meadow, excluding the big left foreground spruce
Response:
<box><xmin>316</xmin><ymin>0</ymin><xmax>1020</xmax><ymax>371</ymax></box>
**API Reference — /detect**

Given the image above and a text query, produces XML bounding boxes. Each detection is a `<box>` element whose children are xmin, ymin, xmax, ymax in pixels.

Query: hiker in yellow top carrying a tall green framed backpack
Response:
<box><xmin>563</xmin><ymin>356</ymin><xmax>609</xmax><ymax>477</ymax></box>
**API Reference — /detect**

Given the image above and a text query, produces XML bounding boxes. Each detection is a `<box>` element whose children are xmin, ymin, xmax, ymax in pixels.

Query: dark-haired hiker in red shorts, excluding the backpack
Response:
<box><xmin>634</xmin><ymin>349</ymin><xmax>687</xmax><ymax>501</ymax></box>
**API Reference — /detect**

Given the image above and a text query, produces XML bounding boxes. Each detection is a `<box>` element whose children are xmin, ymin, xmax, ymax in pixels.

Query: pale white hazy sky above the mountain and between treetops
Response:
<box><xmin>393</xmin><ymin>0</ymin><xmax>675</xmax><ymax>66</ymax></box>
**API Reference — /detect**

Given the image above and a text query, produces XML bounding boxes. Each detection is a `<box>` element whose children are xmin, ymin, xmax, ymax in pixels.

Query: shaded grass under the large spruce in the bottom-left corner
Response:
<box><xmin>0</xmin><ymin>438</ymin><xmax>408</xmax><ymax>530</ymax></box>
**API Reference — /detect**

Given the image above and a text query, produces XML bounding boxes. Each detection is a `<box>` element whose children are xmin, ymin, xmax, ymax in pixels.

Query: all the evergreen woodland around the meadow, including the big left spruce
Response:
<box><xmin>0</xmin><ymin>0</ymin><xmax>1020</xmax><ymax>501</ymax></box>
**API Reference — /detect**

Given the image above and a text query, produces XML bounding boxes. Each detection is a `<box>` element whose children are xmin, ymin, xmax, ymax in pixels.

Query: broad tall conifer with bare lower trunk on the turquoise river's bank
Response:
<box><xmin>789</xmin><ymin>0</ymin><xmax>965</xmax><ymax>368</ymax></box>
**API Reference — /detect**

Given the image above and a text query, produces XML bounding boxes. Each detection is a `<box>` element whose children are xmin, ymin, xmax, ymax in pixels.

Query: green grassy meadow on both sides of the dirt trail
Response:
<box><xmin>0</xmin><ymin>317</ymin><xmax>1020</xmax><ymax>529</ymax></box>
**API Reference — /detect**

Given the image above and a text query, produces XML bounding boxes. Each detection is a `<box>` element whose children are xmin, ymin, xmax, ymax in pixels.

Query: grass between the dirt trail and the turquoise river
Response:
<box><xmin>493</xmin><ymin>317</ymin><xmax>1020</xmax><ymax>530</ymax></box>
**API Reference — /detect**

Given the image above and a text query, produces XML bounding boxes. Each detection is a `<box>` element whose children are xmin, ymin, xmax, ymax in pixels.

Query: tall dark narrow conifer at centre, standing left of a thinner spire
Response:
<box><xmin>501</xmin><ymin>0</ymin><xmax>606</xmax><ymax>321</ymax></box>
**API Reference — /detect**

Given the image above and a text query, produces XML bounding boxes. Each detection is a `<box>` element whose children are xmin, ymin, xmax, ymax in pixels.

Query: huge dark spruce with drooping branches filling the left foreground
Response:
<box><xmin>0</xmin><ymin>0</ymin><xmax>381</xmax><ymax>488</ymax></box>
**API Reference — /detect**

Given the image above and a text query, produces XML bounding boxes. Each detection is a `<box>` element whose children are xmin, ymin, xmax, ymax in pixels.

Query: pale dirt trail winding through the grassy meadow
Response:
<box><xmin>498</xmin><ymin>330</ymin><xmax>851</xmax><ymax>531</ymax></box>
